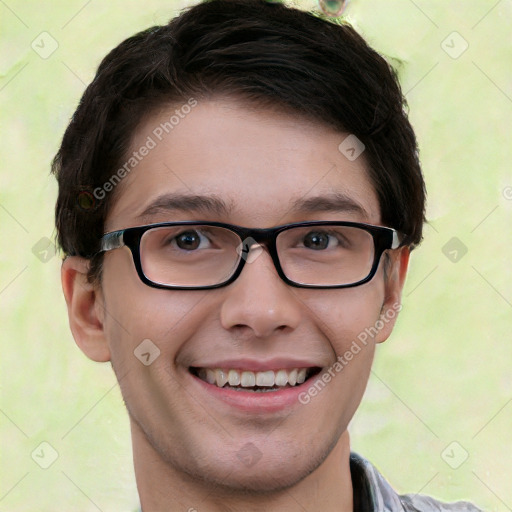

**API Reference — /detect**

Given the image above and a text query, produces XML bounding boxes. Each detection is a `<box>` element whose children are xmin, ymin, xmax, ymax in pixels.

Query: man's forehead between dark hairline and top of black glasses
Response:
<box><xmin>106</xmin><ymin>99</ymin><xmax>380</xmax><ymax>231</ymax></box>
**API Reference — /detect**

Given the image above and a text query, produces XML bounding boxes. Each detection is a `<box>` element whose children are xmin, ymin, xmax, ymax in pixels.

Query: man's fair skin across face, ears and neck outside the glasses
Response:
<box><xmin>62</xmin><ymin>98</ymin><xmax>409</xmax><ymax>512</ymax></box>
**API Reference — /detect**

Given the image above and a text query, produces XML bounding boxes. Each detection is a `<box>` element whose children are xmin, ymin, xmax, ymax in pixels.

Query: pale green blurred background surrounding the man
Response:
<box><xmin>0</xmin><ymin>0</ymin><xmax>512</xmax><ymax>512</ymax></box>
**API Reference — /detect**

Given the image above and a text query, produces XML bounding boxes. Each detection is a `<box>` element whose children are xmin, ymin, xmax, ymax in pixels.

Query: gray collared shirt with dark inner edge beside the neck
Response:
<box><xmin>350</xmin><ymin>453</ymin><xmax>483</xmax><ymax>512</ymax></box>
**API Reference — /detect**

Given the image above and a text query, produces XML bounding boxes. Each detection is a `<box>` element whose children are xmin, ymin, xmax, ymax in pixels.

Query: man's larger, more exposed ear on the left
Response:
<box><xmin>61</xmin><ymin>256</ymin><xmax>110</xmax><ymax>362</ymax></box>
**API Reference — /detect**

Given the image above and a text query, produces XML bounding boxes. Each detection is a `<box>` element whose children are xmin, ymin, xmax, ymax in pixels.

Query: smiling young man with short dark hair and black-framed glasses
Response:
<box><xmin>54</xmin><ymin>0</ymin><xmax>477</xmax><ymax>512</ymax></box>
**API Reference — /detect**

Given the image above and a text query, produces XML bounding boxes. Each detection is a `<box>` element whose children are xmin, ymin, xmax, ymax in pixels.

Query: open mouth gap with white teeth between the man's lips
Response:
<box><xmin>189</xmin><ymin>367</ymin><xmax>321</xmax><ymax>393</ymax></box>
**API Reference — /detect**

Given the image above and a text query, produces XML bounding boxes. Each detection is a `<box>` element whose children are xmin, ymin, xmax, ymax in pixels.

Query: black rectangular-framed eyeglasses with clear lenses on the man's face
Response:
<box><xmin>101</xmin><ymin>221</ymin><xmax>402</xmax><ymax>290</ymax></box>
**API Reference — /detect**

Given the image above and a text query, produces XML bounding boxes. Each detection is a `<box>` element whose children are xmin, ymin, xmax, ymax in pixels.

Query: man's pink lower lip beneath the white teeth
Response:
<box><xmin>187</xmin><ymin>371</ymin><xmax>314</xmax><ymax>414</ymax></box>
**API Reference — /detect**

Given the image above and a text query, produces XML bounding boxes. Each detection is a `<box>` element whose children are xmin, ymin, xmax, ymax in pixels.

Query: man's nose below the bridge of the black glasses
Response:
<box><xmin>221</xmin><ymin>247</ymin><xmax>301</xmax><ymax>338</ymax></box>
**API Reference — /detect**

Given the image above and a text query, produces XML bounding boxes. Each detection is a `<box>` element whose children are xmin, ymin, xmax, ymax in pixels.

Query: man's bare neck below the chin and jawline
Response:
<box><xmin>131</xmin><ymin>421</ymin><xmax>353</xmax><ymax>512</ymax></box>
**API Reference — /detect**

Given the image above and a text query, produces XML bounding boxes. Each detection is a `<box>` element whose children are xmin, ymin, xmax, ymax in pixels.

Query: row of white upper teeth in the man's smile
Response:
<box><xmin>197</xmin><ymin>368</ymin><xmax>308</xmax><ymax>388</ymax></box>
